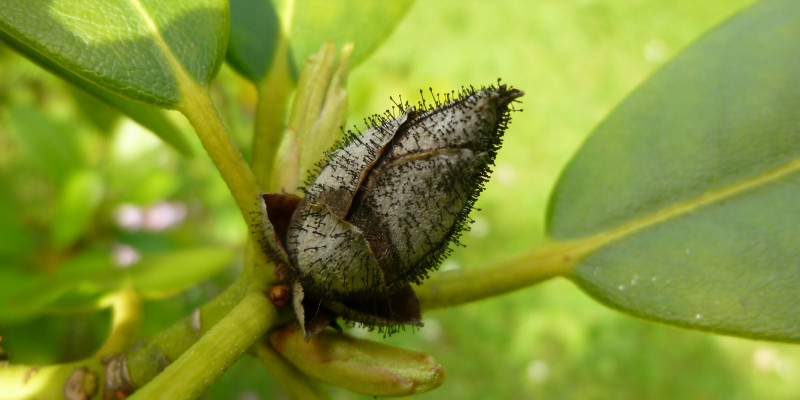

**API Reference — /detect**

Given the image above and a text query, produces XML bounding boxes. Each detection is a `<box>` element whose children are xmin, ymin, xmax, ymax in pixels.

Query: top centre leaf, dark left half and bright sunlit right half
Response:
<box><xmin>227</xmin><ymin>0</ymin><xmax>413</xmax><ymax>82</ymax></box>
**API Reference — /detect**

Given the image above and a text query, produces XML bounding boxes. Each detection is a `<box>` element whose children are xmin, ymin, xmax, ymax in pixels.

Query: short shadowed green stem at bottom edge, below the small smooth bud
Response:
<box><xmin>252</xmin><ymin>339</ymin><xmax>330</xmax><ymax>400</ymax></box>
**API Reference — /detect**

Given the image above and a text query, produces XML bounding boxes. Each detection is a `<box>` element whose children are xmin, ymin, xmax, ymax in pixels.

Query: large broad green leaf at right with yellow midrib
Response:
<box><xmin>548</xmin><ymin>0</ymin><xmax>800</xmax><ymax>342</ymax></box>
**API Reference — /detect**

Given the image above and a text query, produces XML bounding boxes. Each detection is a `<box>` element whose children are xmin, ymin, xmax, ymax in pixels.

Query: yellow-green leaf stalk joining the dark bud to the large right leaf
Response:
<box><xmin>415</xmin><ymin>242</ymin><xmax>584</xmax><ymax>310</ymax></box>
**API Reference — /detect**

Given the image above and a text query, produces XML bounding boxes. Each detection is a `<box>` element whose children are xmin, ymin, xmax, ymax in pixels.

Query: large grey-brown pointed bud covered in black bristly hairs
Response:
<box><xmin>262</xmin><ymin>82</ymin><xmax>523</xmax><ymax>337</ymax></box>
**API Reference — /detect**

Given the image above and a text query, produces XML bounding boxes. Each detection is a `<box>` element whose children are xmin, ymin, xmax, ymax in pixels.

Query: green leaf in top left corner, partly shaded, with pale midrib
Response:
<box><xmin>0</xmin><ymin>0</ymin><xmax>228</xmax><ymax>108</ymax></box>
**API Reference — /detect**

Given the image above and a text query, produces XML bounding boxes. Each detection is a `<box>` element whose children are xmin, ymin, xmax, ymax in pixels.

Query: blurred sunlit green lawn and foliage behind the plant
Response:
<box><xmin>0</xmin><ymin>0</ymin><xmax>800</xmax><ymax>400</ymax></box>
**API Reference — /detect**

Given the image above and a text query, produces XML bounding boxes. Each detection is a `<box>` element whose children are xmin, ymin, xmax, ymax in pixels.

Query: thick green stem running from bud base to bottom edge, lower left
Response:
<box><xmin>129</xmin><ymin>290</ymin><xmax>278</xmax><ymax>400</ymax></box>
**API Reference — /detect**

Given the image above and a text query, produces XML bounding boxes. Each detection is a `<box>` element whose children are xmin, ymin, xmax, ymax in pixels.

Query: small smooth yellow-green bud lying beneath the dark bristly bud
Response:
<box><xmin>269</xmin><ymin>324</ymin><xmax>445</xmax><ymax>396</ymax></box>
